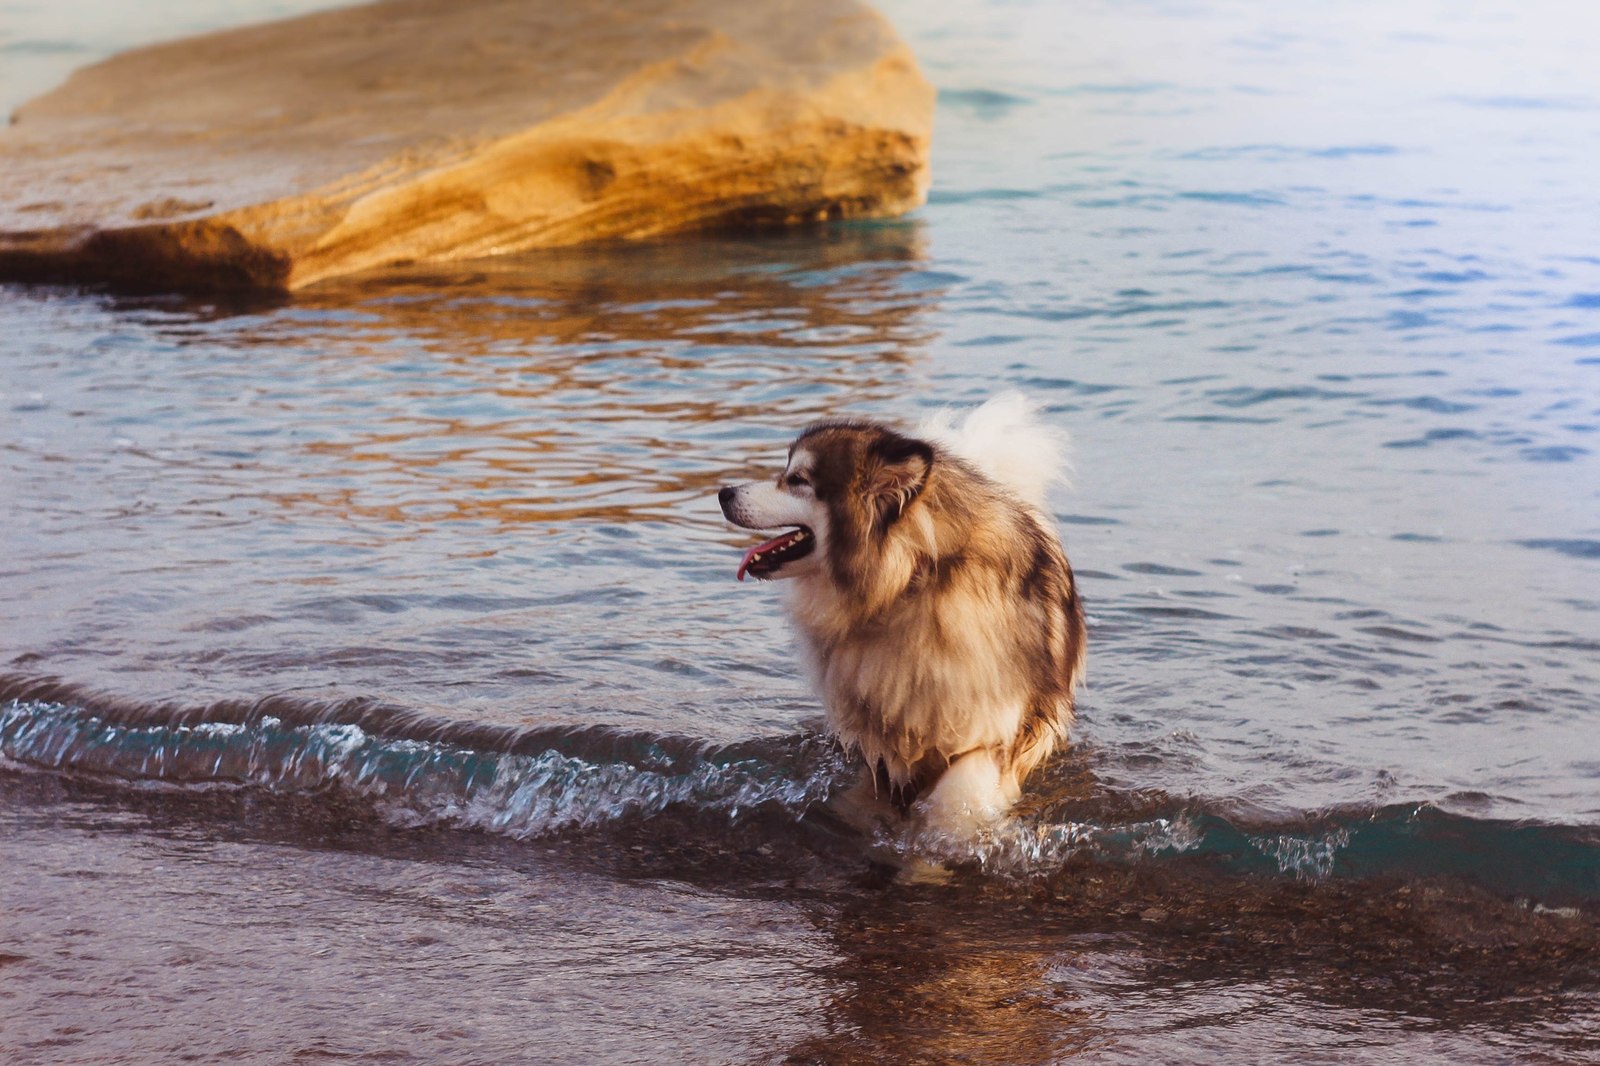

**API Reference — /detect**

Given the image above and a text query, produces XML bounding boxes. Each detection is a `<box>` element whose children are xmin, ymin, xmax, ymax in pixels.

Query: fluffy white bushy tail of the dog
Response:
<box><xmin>917</xmin><ymin>392</ymin><xmax>1072</xmax><ymax>509</ymax></box>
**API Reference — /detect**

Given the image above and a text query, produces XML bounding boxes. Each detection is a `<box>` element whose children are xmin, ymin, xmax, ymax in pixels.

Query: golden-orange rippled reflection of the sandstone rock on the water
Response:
<box><xmin>145</xmin><ymin>224</ymin><xmax>941</xmax><ymax>536</ymax></box>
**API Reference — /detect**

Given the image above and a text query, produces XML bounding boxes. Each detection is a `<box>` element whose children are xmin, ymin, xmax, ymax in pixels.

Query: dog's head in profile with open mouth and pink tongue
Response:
<box><xmin>717</xmin><ymin>421</ymin><xmax>934</xmax><ymax>581</ymax></box>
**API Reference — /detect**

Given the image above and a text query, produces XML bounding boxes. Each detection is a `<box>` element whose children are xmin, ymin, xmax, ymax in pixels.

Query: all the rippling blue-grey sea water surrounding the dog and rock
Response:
<box><xmin>0</xmin><ymin>2</ymin><xmax>1600</xmax><ymax>1063</ymax></box>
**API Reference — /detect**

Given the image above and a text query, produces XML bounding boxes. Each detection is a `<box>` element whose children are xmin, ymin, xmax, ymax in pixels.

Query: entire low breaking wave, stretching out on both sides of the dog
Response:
<box><xmin>0</xmin><ymin>683</ymin><xmax>1600</xmax><ymax>906</ymax></box>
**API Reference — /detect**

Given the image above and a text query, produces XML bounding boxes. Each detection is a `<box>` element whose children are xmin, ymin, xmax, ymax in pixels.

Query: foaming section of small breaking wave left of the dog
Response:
<box><xmin>0</xmin><ymin>688</ymin><xmax>838</xmax><ymax>839</ymax></box>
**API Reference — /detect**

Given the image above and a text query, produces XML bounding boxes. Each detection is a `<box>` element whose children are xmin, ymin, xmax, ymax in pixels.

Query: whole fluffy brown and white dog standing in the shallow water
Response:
<box><xmin>718</xmin><ymin>394</ymin><xmax>1086</xmax><ymax>839</ymax></box>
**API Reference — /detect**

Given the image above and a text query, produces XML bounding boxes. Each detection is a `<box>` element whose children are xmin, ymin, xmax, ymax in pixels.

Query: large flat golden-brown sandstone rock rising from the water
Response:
<box><xmin>0</xmin><ymin>0</ymin><xmax>933</xmax><ymax>288</ymax></box>
